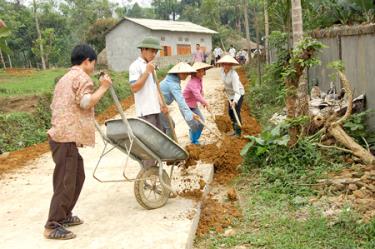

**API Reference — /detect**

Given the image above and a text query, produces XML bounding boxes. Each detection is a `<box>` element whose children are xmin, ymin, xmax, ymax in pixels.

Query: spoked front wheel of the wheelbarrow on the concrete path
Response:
<box><xmin>134</xmin><ymin>167</ymin><xmax>171</xmax><ymax>209</ymax></box>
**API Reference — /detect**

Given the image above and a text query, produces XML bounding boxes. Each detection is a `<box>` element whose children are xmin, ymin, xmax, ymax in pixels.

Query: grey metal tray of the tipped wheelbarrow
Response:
<box><xmin>105</xmin><ymin>118</ymin><xmax>189</xmax><ymax>161</ymax></box>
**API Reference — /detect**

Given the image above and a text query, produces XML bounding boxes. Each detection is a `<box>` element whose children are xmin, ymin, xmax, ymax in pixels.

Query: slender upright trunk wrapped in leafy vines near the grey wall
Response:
<box><xmin>291</xmin><ymin>0</ymin><xmax>309</xmax><ymax>116</ymax></box>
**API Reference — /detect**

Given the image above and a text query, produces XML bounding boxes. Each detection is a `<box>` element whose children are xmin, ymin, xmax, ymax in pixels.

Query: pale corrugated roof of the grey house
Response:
<box><xmin>107</xmin><ymin>17</ymin><xmax>217</xmax><ymax>34</ymax></box>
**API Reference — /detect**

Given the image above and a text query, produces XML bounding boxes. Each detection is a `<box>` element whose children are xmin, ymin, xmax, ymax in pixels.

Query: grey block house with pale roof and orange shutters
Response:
<box><xmin>105</xmin><ymin>18</ymin><xmax>217</xmax><ymax>72</ymax></box>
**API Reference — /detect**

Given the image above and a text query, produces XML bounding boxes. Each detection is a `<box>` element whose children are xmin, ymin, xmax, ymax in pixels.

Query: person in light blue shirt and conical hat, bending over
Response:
<box><xmin>160</xmin><ymin>62</ymin><xmax>203</xmax><ymax>143</ymax></box>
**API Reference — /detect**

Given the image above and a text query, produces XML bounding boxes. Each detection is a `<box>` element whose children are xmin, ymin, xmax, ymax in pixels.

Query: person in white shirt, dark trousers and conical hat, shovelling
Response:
<box><xmin>218</xmin><ymin>55</ymin><xmax>245</xmax><ymax>136</ymax></box>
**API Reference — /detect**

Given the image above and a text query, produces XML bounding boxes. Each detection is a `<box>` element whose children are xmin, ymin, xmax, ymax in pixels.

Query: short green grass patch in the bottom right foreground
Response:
<box><xmin>198</xmin><ymin>175</ymin><xmax>375</xmax><ymax>249</ymax></box>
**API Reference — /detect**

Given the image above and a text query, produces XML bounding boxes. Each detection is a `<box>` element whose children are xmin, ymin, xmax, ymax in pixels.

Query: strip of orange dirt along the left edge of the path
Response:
<box><xmin>0</xmin><ymin>96</ymin><xmax>134</xmax><ymax>175</ymax></box>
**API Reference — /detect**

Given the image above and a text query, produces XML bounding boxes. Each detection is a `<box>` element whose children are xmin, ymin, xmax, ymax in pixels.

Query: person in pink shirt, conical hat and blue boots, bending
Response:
<box><xmin>183</xmin><ymin>62</ymin><xmax>211</xmax><ymax>144</ymax></box>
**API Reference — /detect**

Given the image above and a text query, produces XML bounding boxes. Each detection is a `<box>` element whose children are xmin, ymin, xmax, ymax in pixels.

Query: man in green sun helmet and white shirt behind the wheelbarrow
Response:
<box><xmin>129</xmin><ymin>37</ymin><xmax>168</xmax><ymax>131</ymax></box>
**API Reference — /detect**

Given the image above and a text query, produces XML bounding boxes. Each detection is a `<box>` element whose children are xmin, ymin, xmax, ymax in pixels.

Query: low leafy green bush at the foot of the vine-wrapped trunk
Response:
<box><xmin>241</xmin><ymin>123</ymin><xmax>342</xmax><ymax>196</ymax></box>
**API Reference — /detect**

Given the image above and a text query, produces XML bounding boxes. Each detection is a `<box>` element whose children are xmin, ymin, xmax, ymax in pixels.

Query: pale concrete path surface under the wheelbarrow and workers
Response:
<box><xmin>0</xmin><ymin>69</ymin><xmax>223</xmax><ymax>249</ymax></box>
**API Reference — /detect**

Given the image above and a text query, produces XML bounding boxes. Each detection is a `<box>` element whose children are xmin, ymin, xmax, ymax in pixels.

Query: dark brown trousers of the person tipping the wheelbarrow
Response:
<box><xmin>45</xmin><ymin>139</ymin><xmax>85</xmax><ymax>229</ymax></box>
